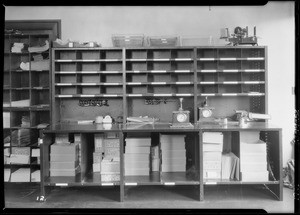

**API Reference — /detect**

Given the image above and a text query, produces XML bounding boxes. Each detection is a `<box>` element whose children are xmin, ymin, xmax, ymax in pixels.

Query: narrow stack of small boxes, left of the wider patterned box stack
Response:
<box><xmin>93</xmin><ymin>134</ymin><xmax>104</xmax><ymax>174</ymax></box>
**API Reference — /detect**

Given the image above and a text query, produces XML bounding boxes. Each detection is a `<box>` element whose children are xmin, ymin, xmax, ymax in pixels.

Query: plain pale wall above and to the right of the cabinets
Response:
<box><xmin>5</xmin><ymin>1</ymin><xmax>295</xmax><ymax>166</ymax></box>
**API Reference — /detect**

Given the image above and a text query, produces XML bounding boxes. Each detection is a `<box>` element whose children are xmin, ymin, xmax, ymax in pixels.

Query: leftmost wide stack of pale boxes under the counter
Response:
<box><xmin>50</xmin><ymin>143</ymin><xmax>80</xmax><ymax>176</ymax></box>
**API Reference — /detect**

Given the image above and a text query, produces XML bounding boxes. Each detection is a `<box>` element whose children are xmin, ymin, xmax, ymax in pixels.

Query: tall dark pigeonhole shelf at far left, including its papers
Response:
<box><xmin>3</xmin><ymin>31</ymin><xmax>51</xmax><ymax>183</ymax></box>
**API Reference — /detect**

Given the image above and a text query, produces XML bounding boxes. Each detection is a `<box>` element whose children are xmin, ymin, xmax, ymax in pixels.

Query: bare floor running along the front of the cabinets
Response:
<box><xmin>5</xmin><ymin>185</ymin><xmax>294</xmax><ymax>213</ymax></box>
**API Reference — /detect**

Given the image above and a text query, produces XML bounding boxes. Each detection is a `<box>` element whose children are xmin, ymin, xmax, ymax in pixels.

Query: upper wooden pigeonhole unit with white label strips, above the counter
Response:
<box><xmin>52</xmin><ymin>46</ymin><xmax>267</xmax><ymax>124</ymax></box>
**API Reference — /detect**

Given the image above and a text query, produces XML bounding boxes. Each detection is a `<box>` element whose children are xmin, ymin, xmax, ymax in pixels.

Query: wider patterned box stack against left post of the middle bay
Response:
<box><xmin>100</xmin><ymin>136</ymin><xmax>120</xmax><ymax>182</ymax></box>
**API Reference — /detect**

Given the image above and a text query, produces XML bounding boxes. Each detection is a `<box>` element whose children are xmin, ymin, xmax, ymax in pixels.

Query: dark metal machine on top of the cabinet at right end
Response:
<box><xmin>220</xmin><ymin>26</ymin><xmax>258</xmax><ymax>46</ymax></box>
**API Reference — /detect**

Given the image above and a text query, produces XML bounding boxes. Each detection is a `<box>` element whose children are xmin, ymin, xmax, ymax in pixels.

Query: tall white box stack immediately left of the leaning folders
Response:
<box><xmin>202</xmin><ymin>132</ymin><xmax>223</xmax><ymax>179</ymax></box>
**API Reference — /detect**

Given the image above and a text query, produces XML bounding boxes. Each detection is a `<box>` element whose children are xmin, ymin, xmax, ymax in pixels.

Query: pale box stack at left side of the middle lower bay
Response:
<box><xmin>124</xmin><ymin>137</ymin><xmax>151</xmax><ymax>176</ymax></box>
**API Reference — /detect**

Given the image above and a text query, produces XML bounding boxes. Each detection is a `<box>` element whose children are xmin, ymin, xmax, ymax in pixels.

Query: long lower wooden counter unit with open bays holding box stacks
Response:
<box><xmin>41</xmin><ymin>122</ymin><xmax>282</xmax><ymax>201</ymax></box>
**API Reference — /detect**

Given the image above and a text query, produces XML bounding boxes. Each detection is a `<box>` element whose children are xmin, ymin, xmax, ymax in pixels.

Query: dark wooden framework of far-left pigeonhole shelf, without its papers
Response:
<box><xmin>3</xmin><ymin>32</ymin><xmax>51</xmax><ymax>184</ymax></box>
